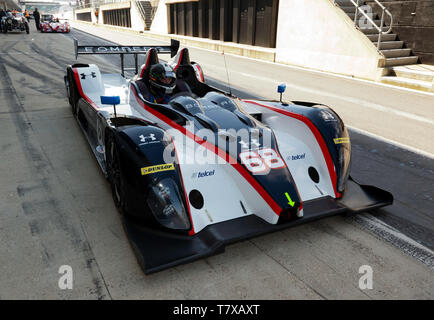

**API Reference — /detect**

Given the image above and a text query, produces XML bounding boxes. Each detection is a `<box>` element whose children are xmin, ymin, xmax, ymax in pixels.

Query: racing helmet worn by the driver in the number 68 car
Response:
<box><xmin>149</xmin><ymin>63</ymin><xmax>176</xmax><ymax>95</ymax></box>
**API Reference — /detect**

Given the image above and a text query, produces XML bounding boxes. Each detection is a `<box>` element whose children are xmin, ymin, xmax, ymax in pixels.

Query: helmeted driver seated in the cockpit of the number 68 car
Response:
<box><xmin>145</xmin><ymin>63</ymin><xmax>176</xmax><ymax>104</ymax></box>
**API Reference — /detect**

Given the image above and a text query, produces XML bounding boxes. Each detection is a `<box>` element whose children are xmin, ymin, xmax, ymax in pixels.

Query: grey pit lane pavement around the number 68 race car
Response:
<box><xmin>0</xmin><ymin>25</ymin><xmax>434</xmax><ymax>299</ymax></box>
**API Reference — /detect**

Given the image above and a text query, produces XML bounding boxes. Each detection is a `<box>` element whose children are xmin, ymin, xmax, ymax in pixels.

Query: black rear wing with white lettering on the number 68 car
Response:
<box><xmin>74</xmin><ymin>39</ymin><xmax>179</xmax><ymax>75</ymax></box>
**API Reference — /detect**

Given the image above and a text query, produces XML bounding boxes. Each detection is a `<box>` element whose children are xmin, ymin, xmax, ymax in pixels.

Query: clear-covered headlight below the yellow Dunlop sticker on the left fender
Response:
<box><xmin>147</xmin><ymin>178</ymin><xmax>190</xmax><ymax>230</ymax></box>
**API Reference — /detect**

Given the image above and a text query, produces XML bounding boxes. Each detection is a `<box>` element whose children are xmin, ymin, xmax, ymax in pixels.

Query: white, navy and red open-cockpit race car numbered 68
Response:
<box><xmin>65</xmin><ymin>40</ymin><xmax>393</xmax><ymax>274</ymax></box>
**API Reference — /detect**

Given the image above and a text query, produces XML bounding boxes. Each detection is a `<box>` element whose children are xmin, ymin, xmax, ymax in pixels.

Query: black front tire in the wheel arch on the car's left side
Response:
<box><xmin>106</xmin><ymin>134</ymin><xmax>125</xmax><ymax>215</ymax></box>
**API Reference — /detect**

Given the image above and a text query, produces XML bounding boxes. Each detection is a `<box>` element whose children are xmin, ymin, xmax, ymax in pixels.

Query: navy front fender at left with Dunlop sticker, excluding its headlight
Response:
<box><xmin>115</xmin><ymin>125</ymin><xmax>191</xmax><ymax>232</ymax></box>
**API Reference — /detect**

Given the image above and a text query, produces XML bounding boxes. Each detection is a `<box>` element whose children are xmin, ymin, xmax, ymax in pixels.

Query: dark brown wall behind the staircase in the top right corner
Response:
<box><xmin>367</xmin><ymin>0</ymin><xmax>434</xmax><ymax>65</ymax></box>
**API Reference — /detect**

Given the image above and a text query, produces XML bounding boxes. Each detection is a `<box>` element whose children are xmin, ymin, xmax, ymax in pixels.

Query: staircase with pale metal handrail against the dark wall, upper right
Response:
<box><xmin>333</xmin><ymin>0</ymin><xmax>419</xmax><ymax>67</ymax></box>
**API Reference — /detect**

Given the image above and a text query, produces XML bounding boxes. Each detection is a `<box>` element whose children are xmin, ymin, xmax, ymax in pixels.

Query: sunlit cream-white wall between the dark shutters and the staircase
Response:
<box><xmin>276</xmin><ymin>0</ymin><xmax>384</xmax><ymax>80</ymax></box>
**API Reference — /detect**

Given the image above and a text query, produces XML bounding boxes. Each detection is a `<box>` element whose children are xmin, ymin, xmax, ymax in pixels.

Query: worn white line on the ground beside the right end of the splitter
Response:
<box><xmin>353</xmin><ymin>213</ymin><xmax>434</xmax><ymax>270</ymax></box>
